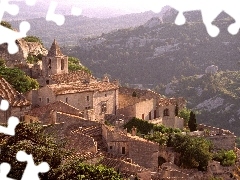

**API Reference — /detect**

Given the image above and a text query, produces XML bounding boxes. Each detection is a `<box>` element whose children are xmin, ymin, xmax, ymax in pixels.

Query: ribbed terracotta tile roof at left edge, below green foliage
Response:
<box><xmin>0</xmin><ymin>77</ymin><xmax>31</xmax><ymax>107</ymax></box>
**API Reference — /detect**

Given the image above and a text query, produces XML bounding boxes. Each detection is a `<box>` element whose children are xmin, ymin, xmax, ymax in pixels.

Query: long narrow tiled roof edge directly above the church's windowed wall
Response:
<box><xmin>48</xmin><ymin>81</ymin><xmax>118</xmax><ymax>95</ymax></box>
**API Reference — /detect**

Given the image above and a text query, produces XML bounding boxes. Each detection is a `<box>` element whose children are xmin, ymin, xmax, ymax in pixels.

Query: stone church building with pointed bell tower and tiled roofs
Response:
<box><xmin>27</xmin><ymin>40</ymin><xmax>119</xmax><ymax>120</ymax></box>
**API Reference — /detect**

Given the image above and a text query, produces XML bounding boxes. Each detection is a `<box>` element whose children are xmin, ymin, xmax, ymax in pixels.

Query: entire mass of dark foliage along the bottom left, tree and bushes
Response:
<box><xmin>0</xmin><ymin>123</ymin><xmax>121</xmax><ymax>180</ymax></box>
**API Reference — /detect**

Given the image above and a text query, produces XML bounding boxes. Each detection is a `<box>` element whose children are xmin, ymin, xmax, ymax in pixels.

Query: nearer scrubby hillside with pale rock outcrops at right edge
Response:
<box><xmin>158</xmin><ymin>71</ymin><xmax>240</xmax><ymax>136</ymax></box>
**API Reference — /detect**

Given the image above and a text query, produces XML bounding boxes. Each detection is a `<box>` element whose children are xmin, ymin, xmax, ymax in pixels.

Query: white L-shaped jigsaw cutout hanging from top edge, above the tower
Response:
<box><xmin>46</xmin><ymin>1</ymin><xmax>65</xmax><ymax>26</ymax></box>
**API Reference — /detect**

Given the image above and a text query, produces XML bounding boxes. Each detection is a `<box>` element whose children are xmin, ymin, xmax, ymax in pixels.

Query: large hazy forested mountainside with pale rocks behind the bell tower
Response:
<box><xmin>64</xmin><ymin>10</ymin><xmax>237</xmax><ymax>88</ymax></box>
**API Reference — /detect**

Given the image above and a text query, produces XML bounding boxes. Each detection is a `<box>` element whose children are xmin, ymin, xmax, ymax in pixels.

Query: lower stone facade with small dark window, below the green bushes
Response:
<box><xmin>102</xmin><ymin>125</ymin><xmax>159</xmax><ymax>171</ymax></box>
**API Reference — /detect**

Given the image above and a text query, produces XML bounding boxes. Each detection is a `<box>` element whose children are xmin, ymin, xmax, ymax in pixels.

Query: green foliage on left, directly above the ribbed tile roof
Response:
<box><xmin>0</xmin><ymin>59</ymin><xmax>39</xmax><ymax>93</ymax></box>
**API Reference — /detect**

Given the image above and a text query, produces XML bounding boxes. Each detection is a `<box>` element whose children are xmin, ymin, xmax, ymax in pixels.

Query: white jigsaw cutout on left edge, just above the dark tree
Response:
<box><xmin>0</xmin><ymin>116</ymin><xmax>19</xmax><ymax>136</ymax></box>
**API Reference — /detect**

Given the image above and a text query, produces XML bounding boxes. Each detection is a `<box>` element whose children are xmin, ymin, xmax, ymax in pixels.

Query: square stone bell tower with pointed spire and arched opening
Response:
<box><xmin>42</xmin><ymin>39</ymin><xmax>68</xmax><ymax>77</ymax></box>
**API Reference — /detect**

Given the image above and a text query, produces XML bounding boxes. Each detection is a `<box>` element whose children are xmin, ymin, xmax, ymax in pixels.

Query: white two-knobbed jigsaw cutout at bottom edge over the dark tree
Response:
<box><xmin>16</xmin><ymin>151</ymin><xmax>50</xmax><ymax>180</ymax></box>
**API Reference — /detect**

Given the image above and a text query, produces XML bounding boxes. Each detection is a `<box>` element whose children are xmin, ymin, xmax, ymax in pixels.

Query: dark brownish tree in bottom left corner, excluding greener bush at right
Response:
<box><xmin>0</xmin><ymin>123</ymin><xmax>68</xmax><ymax>179</ymax></box>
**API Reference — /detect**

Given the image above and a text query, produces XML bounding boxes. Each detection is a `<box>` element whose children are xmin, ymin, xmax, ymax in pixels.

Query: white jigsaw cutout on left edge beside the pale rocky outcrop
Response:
<box><xmin>0</xmin><ymin>21</ymin><xmax>30</xmax><ymax>54</ymax></box>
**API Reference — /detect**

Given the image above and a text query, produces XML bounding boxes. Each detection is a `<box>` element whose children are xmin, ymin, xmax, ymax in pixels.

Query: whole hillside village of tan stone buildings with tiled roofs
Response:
<box><xmin>0</xmin><ymin>40</ymin><xmax>240</xmax><ymax>180</ymax></box>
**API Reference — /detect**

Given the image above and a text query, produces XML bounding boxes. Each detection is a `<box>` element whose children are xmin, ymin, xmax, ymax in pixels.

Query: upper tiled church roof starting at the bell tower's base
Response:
<box><xmin>50</xmin><ymin>70</ymin><xmax>95</xmax><ymax>84</ymax></box>
